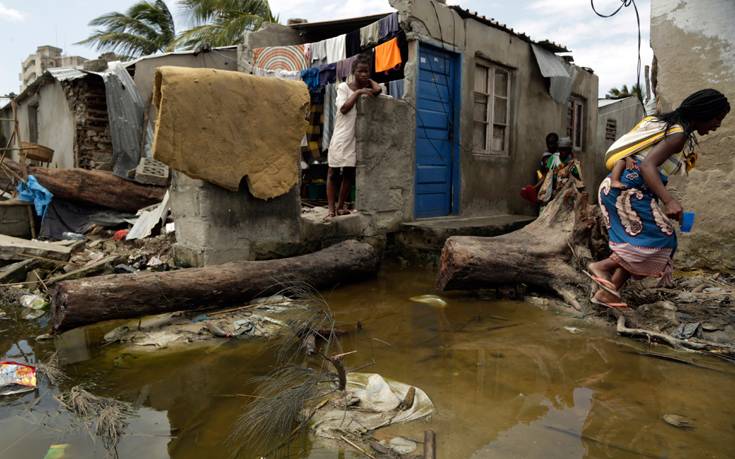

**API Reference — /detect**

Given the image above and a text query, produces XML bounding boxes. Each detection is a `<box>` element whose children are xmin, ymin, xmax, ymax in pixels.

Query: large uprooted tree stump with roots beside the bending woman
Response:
<box><xmin>438</xmin><ymin>184</ymin><xmax>607</xmax><ymax>309</ymax></box>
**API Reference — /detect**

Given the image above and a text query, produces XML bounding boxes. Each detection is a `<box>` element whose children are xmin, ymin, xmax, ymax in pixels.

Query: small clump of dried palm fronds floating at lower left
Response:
<box><xmin>57</xmin><ymin>386</ymin><xmax>131</xmax><ymax>456</ymax></box>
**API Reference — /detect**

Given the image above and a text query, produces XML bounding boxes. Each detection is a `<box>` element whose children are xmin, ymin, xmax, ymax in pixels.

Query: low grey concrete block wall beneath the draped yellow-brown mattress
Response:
<box><xmin>171</xmin><ymin>173</ymin><xmax>301</xmax><ymax>266</ymax></box>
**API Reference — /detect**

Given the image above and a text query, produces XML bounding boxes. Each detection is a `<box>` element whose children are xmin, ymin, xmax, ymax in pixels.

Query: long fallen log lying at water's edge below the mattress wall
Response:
<box><xmin>51</xmin><ymin>241</ymin><xmax>380</xmax><ymax>331</ymax></box>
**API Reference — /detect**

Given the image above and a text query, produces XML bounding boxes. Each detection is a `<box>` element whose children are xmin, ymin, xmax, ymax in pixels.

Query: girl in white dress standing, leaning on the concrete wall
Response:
<box><xmin>327</xmin><ymin>54</ymin><xmax>381</xmax><ymax>218</ymax></box>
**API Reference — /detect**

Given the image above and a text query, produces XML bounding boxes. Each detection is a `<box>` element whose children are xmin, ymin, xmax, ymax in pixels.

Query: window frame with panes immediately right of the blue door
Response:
<box><xmin>472</xmin><ymin>59</ymin><xmax>513</xmax><ymax>157</ymax></box>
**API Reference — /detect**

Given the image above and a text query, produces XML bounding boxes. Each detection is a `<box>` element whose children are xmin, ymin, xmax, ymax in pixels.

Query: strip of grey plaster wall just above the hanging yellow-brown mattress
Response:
<box><xmin>133</xmin><ymin>47</ymin><xmax>237</xmax><ymax>101</ymax></box>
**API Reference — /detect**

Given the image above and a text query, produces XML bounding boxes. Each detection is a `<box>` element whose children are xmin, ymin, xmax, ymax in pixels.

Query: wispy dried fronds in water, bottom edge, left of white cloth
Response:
<box><xmin>227</xmin><ymin>366</ymin><xmax>322</xmax><ymax>457</ymax></box>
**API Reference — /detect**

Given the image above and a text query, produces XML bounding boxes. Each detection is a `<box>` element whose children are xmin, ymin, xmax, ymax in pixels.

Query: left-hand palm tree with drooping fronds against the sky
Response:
<box><xmin>76</xmin><ymin>0</ymin><xmax>176</xmax><ymax>58</ymax></box>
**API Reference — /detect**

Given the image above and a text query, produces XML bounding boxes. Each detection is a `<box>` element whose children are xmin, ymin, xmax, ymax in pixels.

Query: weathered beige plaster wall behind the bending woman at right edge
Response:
<box><xmin>651</xmin><ymin>0</ymin><xmax>735</xmax><ymax>270</ymax></box>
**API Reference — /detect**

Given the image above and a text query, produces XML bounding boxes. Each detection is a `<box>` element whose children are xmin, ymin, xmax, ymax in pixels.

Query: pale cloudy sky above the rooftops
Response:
<box><xmin>0</xmin><ymin>0</ymin><xmax>652</xmax><ymax>95</ymax></box>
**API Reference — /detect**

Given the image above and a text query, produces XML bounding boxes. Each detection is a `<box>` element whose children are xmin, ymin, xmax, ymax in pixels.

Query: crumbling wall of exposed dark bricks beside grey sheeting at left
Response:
<box><xmin>64</xmin><ymin>76</ymin><xmax>112</xmax><ymax>171</ymax></box>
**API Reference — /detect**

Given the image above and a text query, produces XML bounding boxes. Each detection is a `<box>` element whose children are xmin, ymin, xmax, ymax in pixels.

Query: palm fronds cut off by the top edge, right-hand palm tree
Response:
<box><xmin>177</xmin><ymin>0</ymin><xmax>278</xmax><ymax>48</ymax></box>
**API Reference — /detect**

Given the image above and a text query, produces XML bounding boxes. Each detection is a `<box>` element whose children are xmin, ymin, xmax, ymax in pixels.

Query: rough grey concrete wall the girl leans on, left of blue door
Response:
<box><xmin>355</xmin><ymin>97</ymin><xmax>416</xmax><ymax>231</ymax></box>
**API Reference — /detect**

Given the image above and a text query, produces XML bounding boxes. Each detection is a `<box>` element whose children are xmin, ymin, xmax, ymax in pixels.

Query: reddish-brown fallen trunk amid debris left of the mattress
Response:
<box><xmin>3</xmin><ymin>158</ymin><xmax>167</xmax><ymax>212</ymax></box>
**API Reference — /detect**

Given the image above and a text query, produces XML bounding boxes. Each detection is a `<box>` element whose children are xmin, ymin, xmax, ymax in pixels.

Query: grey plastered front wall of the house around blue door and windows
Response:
<box><xmin>391</xmin><ymin>0</ymin><xmax>598</xmax><ymax>217</ymax></box>
